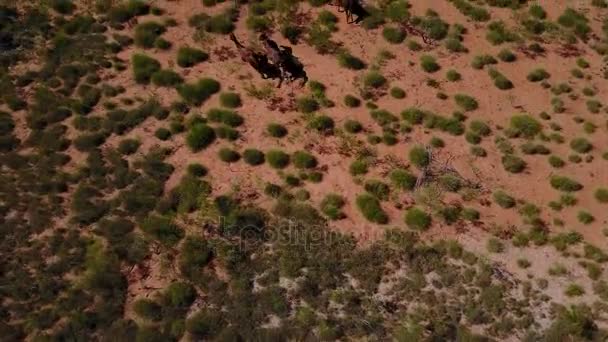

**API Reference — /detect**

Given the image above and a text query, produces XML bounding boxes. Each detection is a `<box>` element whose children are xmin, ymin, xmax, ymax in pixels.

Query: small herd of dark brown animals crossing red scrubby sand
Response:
<box><xmin>230</xmin><ymin>0</ymin><xmax>369</xmax><ymax>88</ymax></box>
